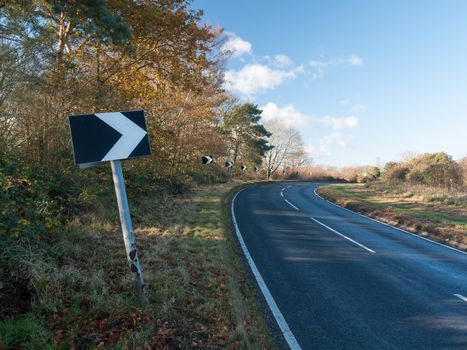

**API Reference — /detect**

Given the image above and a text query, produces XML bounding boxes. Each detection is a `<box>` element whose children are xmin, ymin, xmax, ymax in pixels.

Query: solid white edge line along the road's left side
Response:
<box><xmin>230</xmin><ymin>189</ymin><xmax>301</xmax><ymax>350</ymax></box>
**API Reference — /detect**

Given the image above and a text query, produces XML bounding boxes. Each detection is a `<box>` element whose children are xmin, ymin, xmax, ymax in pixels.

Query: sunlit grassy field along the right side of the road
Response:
<box><xmin>318</xmin><ymin>183</ymin><xmax>467</xmax><ymax>250</ymax></box>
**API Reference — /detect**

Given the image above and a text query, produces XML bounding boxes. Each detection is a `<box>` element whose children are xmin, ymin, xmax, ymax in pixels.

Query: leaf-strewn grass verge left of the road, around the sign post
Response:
<box><xmin>0</xmin><ymin>184</ymin><xmax>274</xmax><ymax>349</ymax></box>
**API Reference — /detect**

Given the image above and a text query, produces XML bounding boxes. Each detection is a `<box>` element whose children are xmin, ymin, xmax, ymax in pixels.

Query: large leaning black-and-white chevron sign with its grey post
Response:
<box><xmin>69</xmin><ymin>111</ymin><xmax>151</xmax><ymax>307</ymax></box>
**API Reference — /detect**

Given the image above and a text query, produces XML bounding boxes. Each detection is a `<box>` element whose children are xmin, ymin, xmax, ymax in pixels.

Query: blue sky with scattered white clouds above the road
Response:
<box><xmin>192</xmin><ymin>0</ymin><xmax>467</xmax><ymax>166</ymax></box>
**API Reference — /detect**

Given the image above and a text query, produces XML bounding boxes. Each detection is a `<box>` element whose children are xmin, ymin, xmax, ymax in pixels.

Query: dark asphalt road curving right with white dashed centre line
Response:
<box><xmin>232</xmin><ymin>182</ymin><xmax>467</xmax><ymax>350</ymax></box>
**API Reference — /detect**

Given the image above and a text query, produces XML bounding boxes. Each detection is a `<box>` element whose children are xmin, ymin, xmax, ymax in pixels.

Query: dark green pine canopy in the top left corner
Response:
<box><xmin>0</xmin><ymin>0</ymin><xmax>131</xmax><ymax>63</ymax></box>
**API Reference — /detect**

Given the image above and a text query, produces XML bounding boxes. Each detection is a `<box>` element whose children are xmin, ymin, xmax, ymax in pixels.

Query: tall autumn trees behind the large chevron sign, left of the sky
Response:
<box><xmin>0</xmin><ymin>0</ymin><xmax>270</xmax><ymax>183</ymax></box>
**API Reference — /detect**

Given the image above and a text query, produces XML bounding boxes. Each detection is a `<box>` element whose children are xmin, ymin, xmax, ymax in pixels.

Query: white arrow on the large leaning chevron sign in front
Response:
<box><xmin>95</xmin><ymin>112</ymin><xmax>147</xmax><ymax>161</ymax></box>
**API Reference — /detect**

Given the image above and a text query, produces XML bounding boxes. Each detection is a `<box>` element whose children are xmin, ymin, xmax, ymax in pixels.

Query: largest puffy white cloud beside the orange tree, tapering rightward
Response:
<box><xmin>224</xmin><ymin>63</ymin><xmax>299</xmax><ymax>96</ymax></box>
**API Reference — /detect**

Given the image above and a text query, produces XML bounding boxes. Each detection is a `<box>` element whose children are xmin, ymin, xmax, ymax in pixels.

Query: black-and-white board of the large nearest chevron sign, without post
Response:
<box><xmin>69</xmin><ymin>111</ymin><xmax>151</xmax><ymax>166</ymax></box>
